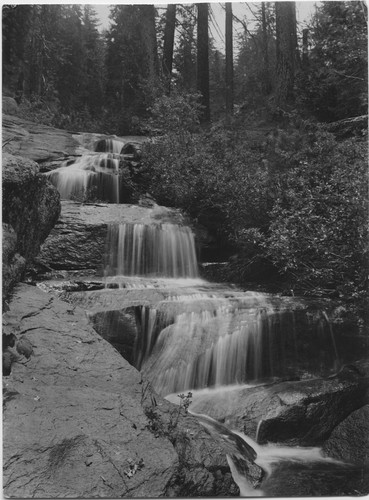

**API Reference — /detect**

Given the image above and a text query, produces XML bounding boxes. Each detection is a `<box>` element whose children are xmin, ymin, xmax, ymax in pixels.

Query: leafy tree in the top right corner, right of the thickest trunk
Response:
<box><xmin>298</xmin><ymin>1</ymin><xmax>368</xmax><ymax>121</ymax></box>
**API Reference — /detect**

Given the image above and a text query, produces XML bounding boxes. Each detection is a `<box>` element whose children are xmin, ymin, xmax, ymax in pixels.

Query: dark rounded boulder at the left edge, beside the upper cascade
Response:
<box><xmin>2</xmin><ymin>153</ymin><xmax>60</xmax><ymax>296</ymax></box>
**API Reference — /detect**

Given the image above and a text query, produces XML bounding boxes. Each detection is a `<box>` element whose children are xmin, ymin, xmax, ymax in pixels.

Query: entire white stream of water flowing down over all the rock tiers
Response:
<box><xmin>48</xmin><ymin>136</ymin><xmax>362</xmax><ymax>496</ymax></box>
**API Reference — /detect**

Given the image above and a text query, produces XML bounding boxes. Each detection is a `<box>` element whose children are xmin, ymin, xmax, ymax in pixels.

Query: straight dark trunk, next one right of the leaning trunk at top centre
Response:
<box><xmin>197</xmin><ymin>3</ymin><xmax>210</xmax><ymax>123</ymax></box>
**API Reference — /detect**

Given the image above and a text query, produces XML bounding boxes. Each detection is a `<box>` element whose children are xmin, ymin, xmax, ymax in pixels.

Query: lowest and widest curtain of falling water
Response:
<box><xmin>140</xmin><ymin>294</ymin><xmax>337</xmax><ymax>395</ymax></box>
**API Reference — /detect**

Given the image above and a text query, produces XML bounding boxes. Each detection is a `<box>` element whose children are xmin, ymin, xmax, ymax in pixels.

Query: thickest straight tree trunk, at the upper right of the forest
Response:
<box><xmin>275</xmin><ymin>2</ymin><xmax>297</xmax><ymax>107</ymax></box>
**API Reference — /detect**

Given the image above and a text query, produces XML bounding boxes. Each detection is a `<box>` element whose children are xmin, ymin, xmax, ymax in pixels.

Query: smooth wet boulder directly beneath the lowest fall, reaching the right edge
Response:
<box><xmin>191</xmin><ymin>362</ymin><xmax>369</xmax><ymax>446</ymax></box>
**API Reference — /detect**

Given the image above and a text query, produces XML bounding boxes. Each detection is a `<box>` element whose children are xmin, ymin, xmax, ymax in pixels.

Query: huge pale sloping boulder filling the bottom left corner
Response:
<box><xmin>3</xmin><ymin>284</ymin><xmax>247</xmax><ymax>498</ymax></box>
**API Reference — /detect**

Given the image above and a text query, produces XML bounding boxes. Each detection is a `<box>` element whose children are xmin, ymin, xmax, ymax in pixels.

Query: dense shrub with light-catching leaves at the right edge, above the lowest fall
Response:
<box><xmin>264</xmin><ymin>133</ymin><xmax>368</xmax><ymax>308</ymax></box>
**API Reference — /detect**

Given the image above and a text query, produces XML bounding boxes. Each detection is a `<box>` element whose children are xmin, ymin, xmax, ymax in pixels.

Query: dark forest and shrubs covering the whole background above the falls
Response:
<box><xmin>2</xmin><ymin>1</ymin><xmax>368</xmax><ymax>320</ymax></box>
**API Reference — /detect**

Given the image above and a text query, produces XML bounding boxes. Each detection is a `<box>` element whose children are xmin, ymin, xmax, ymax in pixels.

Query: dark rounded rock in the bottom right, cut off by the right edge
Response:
<box><xmin>323</xmin><ymin>404</ymin><xmax>369</xmax><ymax>465</ymax></box>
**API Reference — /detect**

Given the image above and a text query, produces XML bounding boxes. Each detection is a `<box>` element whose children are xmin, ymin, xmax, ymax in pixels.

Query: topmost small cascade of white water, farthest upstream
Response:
<box><xmin>45</xmin><ymin>139</ymin><xmax>123</xmax><ymax>203</ymax></box>
